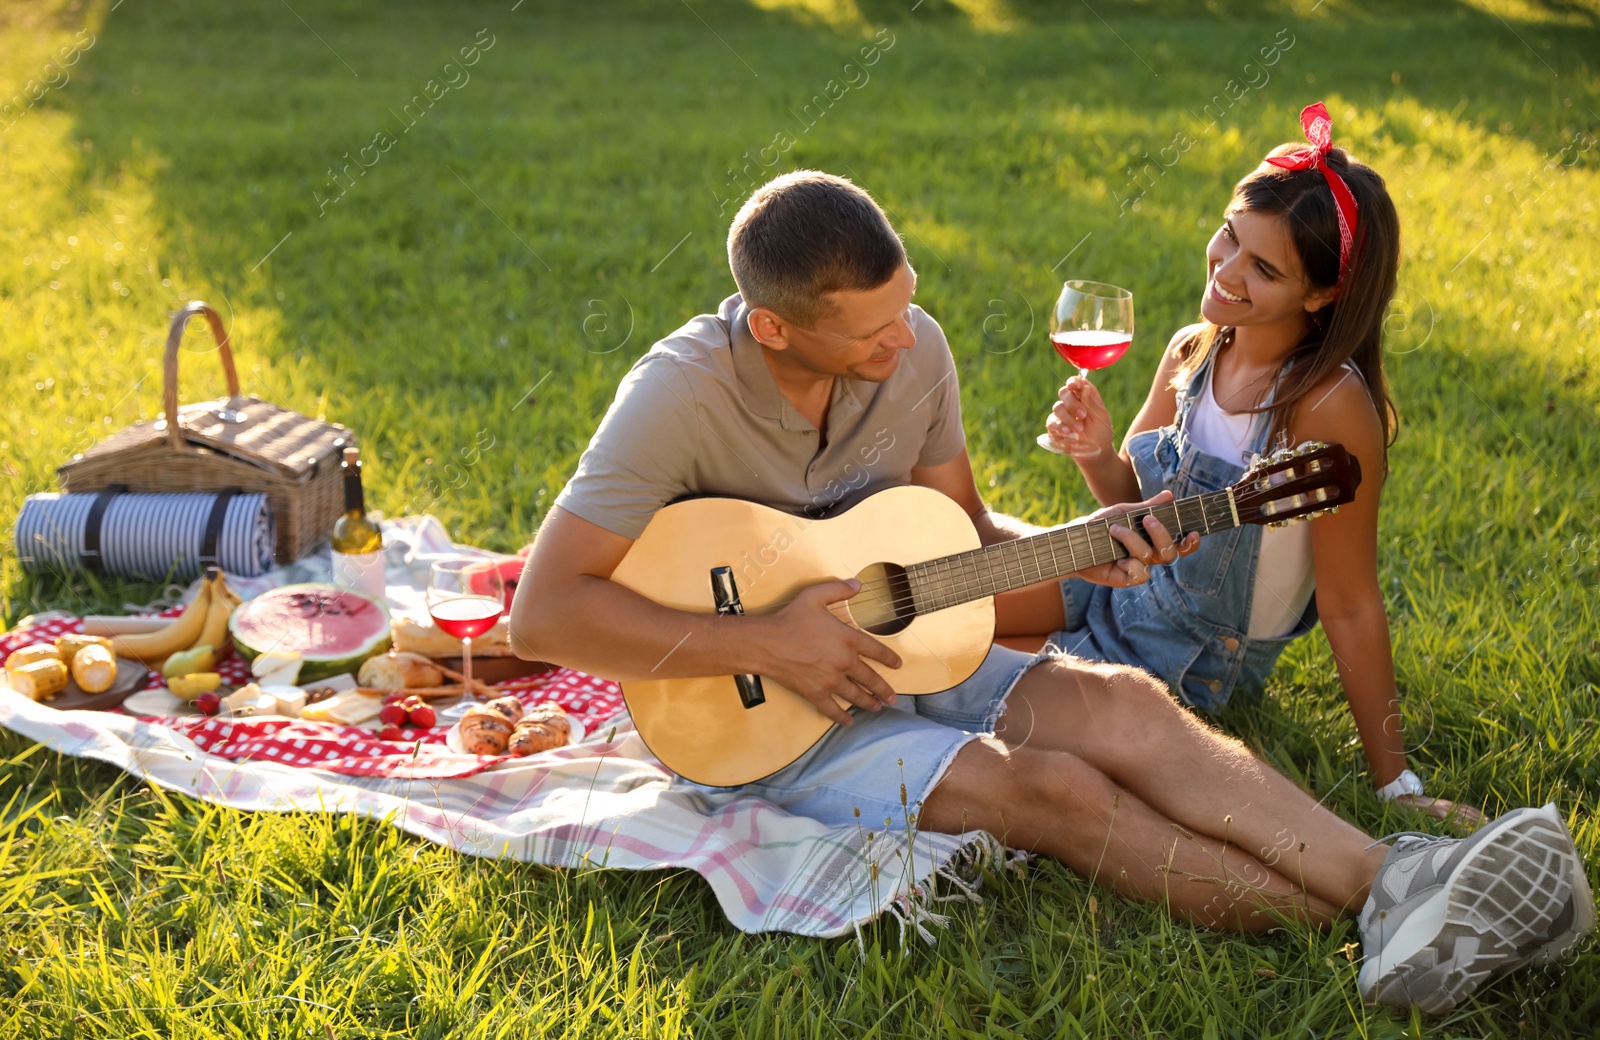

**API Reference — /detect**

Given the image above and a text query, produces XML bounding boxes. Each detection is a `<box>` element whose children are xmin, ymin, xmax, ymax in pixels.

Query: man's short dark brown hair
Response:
<box><xmin>728</xmin><ymin>170</ymin><xmax>906</xmax><ymax>326</ymax></box>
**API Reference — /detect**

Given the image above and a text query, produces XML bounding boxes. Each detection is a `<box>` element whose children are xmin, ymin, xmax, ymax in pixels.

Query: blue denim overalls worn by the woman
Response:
<box><xmin>1050</xmin><ymin>352</ymin><xmax>1317</xmax><ymax>710</ymax></box>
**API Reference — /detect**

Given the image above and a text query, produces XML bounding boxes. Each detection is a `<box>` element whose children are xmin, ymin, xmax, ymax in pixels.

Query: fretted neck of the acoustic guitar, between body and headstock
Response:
<box><xmin>906</xmin><ymin>490</ymin><xmax>1240</xmax><ymax>614</ymax></box>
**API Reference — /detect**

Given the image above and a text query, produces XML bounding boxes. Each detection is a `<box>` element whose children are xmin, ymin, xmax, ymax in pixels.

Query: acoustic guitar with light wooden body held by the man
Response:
<box><xmin>611</xmin><ymin>442</ymin><xmax>1362</xmax><ymax>787</ymax></box>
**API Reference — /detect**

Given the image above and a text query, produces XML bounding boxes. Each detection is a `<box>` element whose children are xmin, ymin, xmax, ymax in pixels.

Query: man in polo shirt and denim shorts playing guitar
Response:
<box><xmin>510</xmin><ymin>171</ymin><xmax>1594</xmax><ymax>1011</ymax></box>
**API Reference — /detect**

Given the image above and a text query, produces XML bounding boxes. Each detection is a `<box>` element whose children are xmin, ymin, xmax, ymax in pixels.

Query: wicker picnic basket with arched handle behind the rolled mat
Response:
<box><xmin>56</xmin><ymin>301</ymin><xmax>355</xmax><ymax>563</ymax></box>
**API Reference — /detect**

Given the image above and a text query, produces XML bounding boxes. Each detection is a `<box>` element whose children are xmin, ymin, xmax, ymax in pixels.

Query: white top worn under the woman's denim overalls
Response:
<box><xmin>1184</xmin><ymin>362</ymin><xmax>1360</xmax><ymax>638</ymax></box>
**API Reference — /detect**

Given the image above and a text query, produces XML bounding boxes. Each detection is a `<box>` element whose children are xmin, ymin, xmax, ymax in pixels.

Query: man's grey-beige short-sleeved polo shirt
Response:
<box><xmin>555</xmin><ymin>294</ymin><xmax>966</xmax><ymax>538</ymax></box>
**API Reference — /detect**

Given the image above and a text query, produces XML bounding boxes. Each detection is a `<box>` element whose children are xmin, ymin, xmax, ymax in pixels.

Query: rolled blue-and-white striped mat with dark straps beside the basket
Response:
<box><xmin>16</xmin><ymin>488</ymin><xmax>277</xmax><ymax>579</ymax></box>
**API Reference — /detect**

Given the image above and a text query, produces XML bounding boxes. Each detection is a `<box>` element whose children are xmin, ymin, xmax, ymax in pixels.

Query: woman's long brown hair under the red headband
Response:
<box><xmin>1173</xmin><ymin>144</ymin><xmax>1400</xmax><ymax>461</ymax></box>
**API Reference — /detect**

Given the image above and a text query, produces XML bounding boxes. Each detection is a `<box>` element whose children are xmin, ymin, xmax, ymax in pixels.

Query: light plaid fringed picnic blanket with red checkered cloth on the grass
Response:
<box><xmin>0</xmin><ymin>517</ymin><xmax>1005</xmax><ymax>941</ymax></box>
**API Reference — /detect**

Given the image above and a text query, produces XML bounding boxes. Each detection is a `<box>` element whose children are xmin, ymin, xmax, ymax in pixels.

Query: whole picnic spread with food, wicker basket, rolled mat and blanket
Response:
<box><xmin>0</xmin><ymin>302</ymin><xmax>1014</xmax><ymax>941</ymax></box>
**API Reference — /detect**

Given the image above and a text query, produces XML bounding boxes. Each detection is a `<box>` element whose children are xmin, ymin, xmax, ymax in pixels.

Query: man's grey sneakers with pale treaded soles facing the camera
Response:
<box><xmin>1360</xmin><ymin>805</ymin><xmax>1595</xmax><ymax>1014</ymax></box>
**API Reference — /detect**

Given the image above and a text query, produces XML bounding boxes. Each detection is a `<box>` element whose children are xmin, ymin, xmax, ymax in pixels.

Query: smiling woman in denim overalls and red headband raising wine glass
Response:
<box><xmin>997</xmin><ymin>104</ymin><xmax>1482</xmax><ymax>821</ymax></box>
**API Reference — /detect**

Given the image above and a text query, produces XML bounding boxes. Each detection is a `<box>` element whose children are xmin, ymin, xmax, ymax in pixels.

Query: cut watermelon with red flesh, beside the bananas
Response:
<box><xmin>227</xmin><ymin>584</ymin><xmax>389</xmax><ymax>685</ymax></box>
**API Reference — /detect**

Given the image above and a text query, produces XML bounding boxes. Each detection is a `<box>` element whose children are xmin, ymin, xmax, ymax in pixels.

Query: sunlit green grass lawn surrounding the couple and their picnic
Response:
<box><xmin>0</xmin><ymin>0</ymin><xmax>1600</xmax><ymax>1037</ymax></box>
